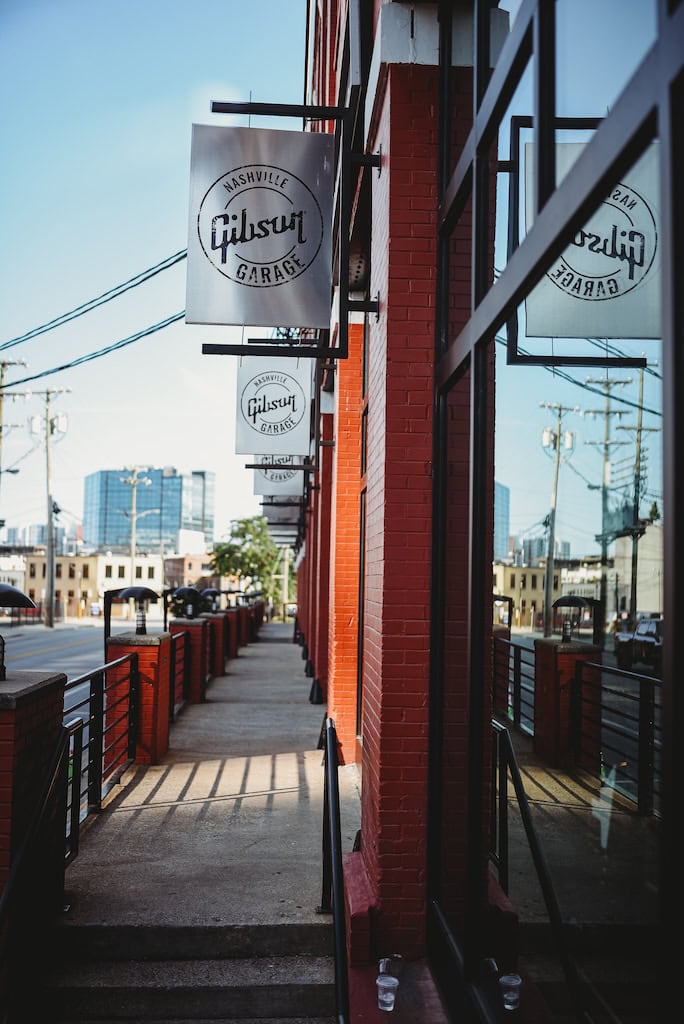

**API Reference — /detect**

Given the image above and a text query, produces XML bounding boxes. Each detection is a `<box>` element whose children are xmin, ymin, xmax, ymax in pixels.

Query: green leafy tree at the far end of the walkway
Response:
<box><xmin>211</xmin><ymin>515</ymin><xmax>283</xmax><ymax>603</ymax></box>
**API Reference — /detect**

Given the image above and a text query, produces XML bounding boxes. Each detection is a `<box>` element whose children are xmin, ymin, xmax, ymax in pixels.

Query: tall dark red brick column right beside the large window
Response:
<box><xmin>361</xmin><ymin>65</ymin><xmax>437</xmax><ymax>954</ymax></box>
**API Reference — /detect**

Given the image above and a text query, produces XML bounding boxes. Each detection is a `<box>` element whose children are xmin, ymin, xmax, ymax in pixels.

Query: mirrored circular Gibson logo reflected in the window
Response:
<box><xmin>547</xmin><ymin>183</ymin><xmax>657</xmax><ymax>302</ymax></box>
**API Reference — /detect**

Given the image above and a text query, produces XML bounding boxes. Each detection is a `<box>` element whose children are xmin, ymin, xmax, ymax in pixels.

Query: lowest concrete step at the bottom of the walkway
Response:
<box><xmin>40</xmin><ymin>955</ymin><xmax>335</xmax><ymax>1024</ymax></box>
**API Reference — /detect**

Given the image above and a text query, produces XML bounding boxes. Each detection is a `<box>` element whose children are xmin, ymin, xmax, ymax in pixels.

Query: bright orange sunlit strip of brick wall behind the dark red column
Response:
<box><xmin>328</xmin><ymin>324</ymin><xmax>364</xmax><ymax>764</ymax></box>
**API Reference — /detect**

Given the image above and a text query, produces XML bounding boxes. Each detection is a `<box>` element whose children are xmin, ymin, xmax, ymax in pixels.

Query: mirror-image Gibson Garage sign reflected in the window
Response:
<box><xmin>525</xmin><ymin>142</ymin><xmax>660</xmax><ymax>338</ymax></box>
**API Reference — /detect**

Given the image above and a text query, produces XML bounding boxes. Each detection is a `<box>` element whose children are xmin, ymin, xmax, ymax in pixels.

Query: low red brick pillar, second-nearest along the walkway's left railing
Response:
<box><xmin>105</xmin><ymin>633</ymin><xmax>171</xmax><ymax>765</ymax></box>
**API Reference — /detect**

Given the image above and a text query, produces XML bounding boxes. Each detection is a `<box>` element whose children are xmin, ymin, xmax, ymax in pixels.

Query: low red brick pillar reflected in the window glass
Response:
<box><xmin>533</xmin><ymin>637</ymin><xmax>601</xmax><ymax>768</ymax></box>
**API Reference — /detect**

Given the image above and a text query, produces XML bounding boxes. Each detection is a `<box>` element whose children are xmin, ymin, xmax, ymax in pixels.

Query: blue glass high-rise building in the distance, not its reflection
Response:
<box><xmin>83</xmin><ymin>466</ymin><xmax>215</xmax><ymax>551</ymax></box>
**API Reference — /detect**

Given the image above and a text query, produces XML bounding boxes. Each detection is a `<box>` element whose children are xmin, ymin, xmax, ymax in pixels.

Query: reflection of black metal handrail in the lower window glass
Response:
<box><xmin>489</xmin><ymin>720</ymin><xmax>593</xmax><ymax>1024</ymax></box>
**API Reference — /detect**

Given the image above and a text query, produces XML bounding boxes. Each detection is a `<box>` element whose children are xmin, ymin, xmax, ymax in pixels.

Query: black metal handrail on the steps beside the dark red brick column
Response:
<box><xmin>318</xmin><ymin>718</ymin><xmax>349</xmax><ymax>1024</ymax></box>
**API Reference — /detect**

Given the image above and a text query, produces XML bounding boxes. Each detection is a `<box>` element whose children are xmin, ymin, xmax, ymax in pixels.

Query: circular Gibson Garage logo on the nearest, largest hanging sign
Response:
<box><xmin>198</xmin><ymin>164</ymin><xmax>324</xmax><ymax>288</ymax></box>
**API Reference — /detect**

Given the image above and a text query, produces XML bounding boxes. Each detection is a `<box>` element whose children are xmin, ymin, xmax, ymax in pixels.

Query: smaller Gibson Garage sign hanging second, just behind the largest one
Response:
<box><xmin>236</xmin><ymin>355</ymin><xmax>312</xmax><ymax>457</ymax></box>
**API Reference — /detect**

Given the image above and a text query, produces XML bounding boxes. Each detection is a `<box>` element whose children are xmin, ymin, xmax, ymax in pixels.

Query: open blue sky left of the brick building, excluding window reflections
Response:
<box><xmin>0</xmin><ymin>0</ymin><xmax>306</xmax><ymax>538</ymax></box>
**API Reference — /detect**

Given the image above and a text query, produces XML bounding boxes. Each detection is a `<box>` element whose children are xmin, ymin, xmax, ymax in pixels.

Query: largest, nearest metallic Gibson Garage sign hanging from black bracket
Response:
<box><xmin>185</xmin><ymin>125</ymin><xmax>334</xmax><ymax>328</ymax></box>
